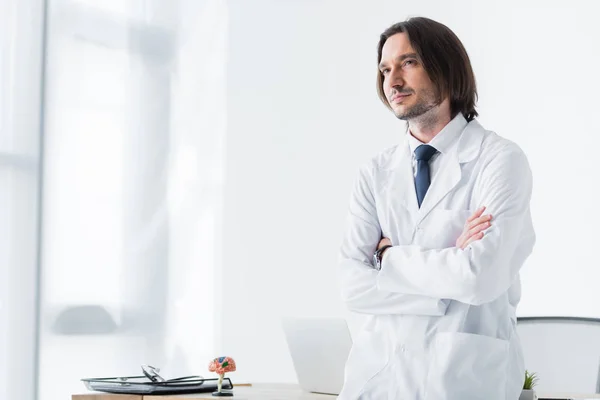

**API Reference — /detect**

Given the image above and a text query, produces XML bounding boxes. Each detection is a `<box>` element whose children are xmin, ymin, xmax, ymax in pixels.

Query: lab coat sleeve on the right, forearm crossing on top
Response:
<box><xmin>377</xmin><ymin>143</ymin><xmax>535</xmax><ymax>305</ymax></box>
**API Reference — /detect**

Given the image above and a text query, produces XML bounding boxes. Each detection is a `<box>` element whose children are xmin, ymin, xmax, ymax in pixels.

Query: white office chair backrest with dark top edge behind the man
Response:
<box><xmin>517</xmin><ymin>317</ymin><xmax>600</xmax><ymax>393</ymax></box>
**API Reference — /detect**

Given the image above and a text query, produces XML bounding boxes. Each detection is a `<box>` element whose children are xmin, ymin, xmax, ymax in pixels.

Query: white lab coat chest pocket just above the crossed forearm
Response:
<box><xmin>418</xmin><ymin>209</ymin><xmax>474</xmax><ymax>249</ymax></box>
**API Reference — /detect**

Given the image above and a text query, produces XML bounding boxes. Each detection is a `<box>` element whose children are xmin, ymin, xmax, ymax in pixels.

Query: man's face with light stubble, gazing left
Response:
<box><xmin>379</xmin><ymin>33</ymin><xmax>438</xmax><ymax>120</ymax></box>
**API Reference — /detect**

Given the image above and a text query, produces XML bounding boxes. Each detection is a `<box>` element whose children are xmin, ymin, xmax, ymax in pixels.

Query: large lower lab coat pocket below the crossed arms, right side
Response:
<box><xmin>425</xmin><ymin>332</ymin><xmax>509</xmax><ymax>400</ymax></box>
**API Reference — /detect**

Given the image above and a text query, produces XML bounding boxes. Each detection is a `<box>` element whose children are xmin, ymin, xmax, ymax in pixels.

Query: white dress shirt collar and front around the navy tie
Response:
<box><xmin>406</xmin><ymin>114</ymin><xmax>467</xmax><ymax>182</ymax></box>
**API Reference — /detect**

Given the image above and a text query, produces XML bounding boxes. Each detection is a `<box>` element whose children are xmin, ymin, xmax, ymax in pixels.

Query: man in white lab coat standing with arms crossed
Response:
<box><xmin>339</xmin><ymin>18</ymin><xmax>535</xmax><ymax>400</ymax></box>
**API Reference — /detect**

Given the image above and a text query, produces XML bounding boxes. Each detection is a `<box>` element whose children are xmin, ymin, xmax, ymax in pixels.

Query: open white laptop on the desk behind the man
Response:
<box><xmin>282</xmin><ymin>318</ymin><xmax>352</xmax><ymax>395</ymax></box>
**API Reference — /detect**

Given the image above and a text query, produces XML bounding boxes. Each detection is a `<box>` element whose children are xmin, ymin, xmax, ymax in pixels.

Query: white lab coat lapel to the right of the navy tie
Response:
<box><xmin>415</xmin><ymin>120</ymin><xmax>485</xmax><ymax>224</ymax></box>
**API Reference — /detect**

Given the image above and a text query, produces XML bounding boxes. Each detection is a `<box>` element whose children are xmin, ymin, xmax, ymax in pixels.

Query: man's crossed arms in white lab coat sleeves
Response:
<box><xmin>339</xmin><ymin>145</ymin><xmax>535</xmax><ymax>316</ymax></box>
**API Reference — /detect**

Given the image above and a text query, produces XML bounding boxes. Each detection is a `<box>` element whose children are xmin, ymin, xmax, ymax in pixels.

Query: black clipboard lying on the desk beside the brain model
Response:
<box><xmin>82</xmin><ymin>376</ymin><xmax>233</xmax><ymax>395</ymax></box>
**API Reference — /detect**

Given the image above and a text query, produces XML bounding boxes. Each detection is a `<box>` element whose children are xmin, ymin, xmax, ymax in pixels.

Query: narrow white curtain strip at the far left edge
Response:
<box><xmin>0</xmin><ymin>0</ymin><xmax>43</xmax><ymax>400</ymax></box>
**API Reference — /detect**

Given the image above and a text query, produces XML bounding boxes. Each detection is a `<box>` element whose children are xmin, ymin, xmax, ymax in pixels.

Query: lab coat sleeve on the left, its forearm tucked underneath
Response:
<box><xmin>339</xmin><ymin>162</ymin><xmax>449</xmax><ymax>316</ymax></box>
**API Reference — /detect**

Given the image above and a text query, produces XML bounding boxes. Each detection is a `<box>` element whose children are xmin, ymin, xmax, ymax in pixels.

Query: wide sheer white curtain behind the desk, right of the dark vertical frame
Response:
<box><xmin>0</xmin><ymin>0</ymin><xmax>227</xmax><ymax>400</ymax></box>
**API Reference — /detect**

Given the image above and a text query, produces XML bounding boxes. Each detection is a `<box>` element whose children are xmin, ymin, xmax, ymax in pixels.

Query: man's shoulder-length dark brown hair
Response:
<box><xmin>377</xmin><ymin>17</ymin><xmax>478</xmax><ymax>121</ymax></box>
